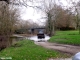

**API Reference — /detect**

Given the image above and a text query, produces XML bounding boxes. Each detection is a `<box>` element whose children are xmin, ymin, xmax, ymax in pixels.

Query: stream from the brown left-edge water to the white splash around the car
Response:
<box><xmin>0</xmin><ymin>35</ymin><xmax>50</xmax><ymax>50</ymax></box>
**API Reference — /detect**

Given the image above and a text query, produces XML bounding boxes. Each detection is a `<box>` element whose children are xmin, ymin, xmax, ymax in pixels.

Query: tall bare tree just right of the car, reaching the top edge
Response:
<box><xmin>40</xmin><ymin>0</ymin><xmax>56</xmax><ymax>36</ymax></box>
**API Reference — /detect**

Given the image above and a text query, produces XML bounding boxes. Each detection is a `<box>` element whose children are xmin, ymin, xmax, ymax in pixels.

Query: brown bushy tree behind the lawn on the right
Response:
<box><xmin>56</xmin><ymin>6</ymin><xmax>75</xmax><ymax>30</ymax></box>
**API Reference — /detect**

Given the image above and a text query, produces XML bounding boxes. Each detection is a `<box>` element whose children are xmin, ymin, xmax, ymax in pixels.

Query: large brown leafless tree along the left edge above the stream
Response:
<box><xmin>0</xmin><ymin>2</ymin><xmax>19</xmax><ymax>48</ymax></box>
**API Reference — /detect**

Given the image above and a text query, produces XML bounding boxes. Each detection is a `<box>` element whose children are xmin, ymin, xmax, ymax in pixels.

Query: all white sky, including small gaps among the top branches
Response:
<box><xmin>20</xmin><ymin>0</ymin><xmax>78</xmax><ymax>24</ymax></box>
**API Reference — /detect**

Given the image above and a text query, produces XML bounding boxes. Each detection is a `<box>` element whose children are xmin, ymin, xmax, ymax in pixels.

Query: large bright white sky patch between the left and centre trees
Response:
<box><xmin>20</xmin><ymin>3</ymin><xmax>45</xmax><ymax>25</ymax></box>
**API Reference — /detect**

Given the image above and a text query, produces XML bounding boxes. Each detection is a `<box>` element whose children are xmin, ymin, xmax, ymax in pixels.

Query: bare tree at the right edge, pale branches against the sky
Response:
<box><xmin>66</xmin><ymin>0</ymin><xmax>80</xmax><ymax>34</ymax></box>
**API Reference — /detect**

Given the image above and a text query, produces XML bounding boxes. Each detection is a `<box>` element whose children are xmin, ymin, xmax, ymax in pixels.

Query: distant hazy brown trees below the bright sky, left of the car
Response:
<box><xmin>15</xmin><ymin>20</ymin><xmax>40</xmax><ymax>34</ymax></box>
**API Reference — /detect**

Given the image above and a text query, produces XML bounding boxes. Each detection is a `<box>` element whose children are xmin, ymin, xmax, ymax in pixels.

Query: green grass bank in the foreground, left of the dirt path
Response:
<box><xmin>0</xmin><ymin>40</ymin><xmax>67</xmax><ymax>60</ymax></box>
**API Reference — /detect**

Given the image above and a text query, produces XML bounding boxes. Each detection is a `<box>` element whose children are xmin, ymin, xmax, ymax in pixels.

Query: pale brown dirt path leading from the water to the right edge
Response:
<box><xmin>35</xmin><ymin>42</ymin><xmax>80</xmax><ymax>55</ymax></box>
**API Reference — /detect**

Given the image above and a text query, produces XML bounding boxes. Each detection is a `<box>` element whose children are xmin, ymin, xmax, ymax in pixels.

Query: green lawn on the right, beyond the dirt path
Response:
<box><xmin>49</xmin><ymin>31</ymin><xmax>80</xmax><ymax>45</ymax></box>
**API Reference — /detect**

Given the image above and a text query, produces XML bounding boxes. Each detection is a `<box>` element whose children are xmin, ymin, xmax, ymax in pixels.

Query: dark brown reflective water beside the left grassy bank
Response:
<box><xmin>0</xmin><ymin>37</ymin><xmax>24</xmax><ymax>50</ymax></box>
